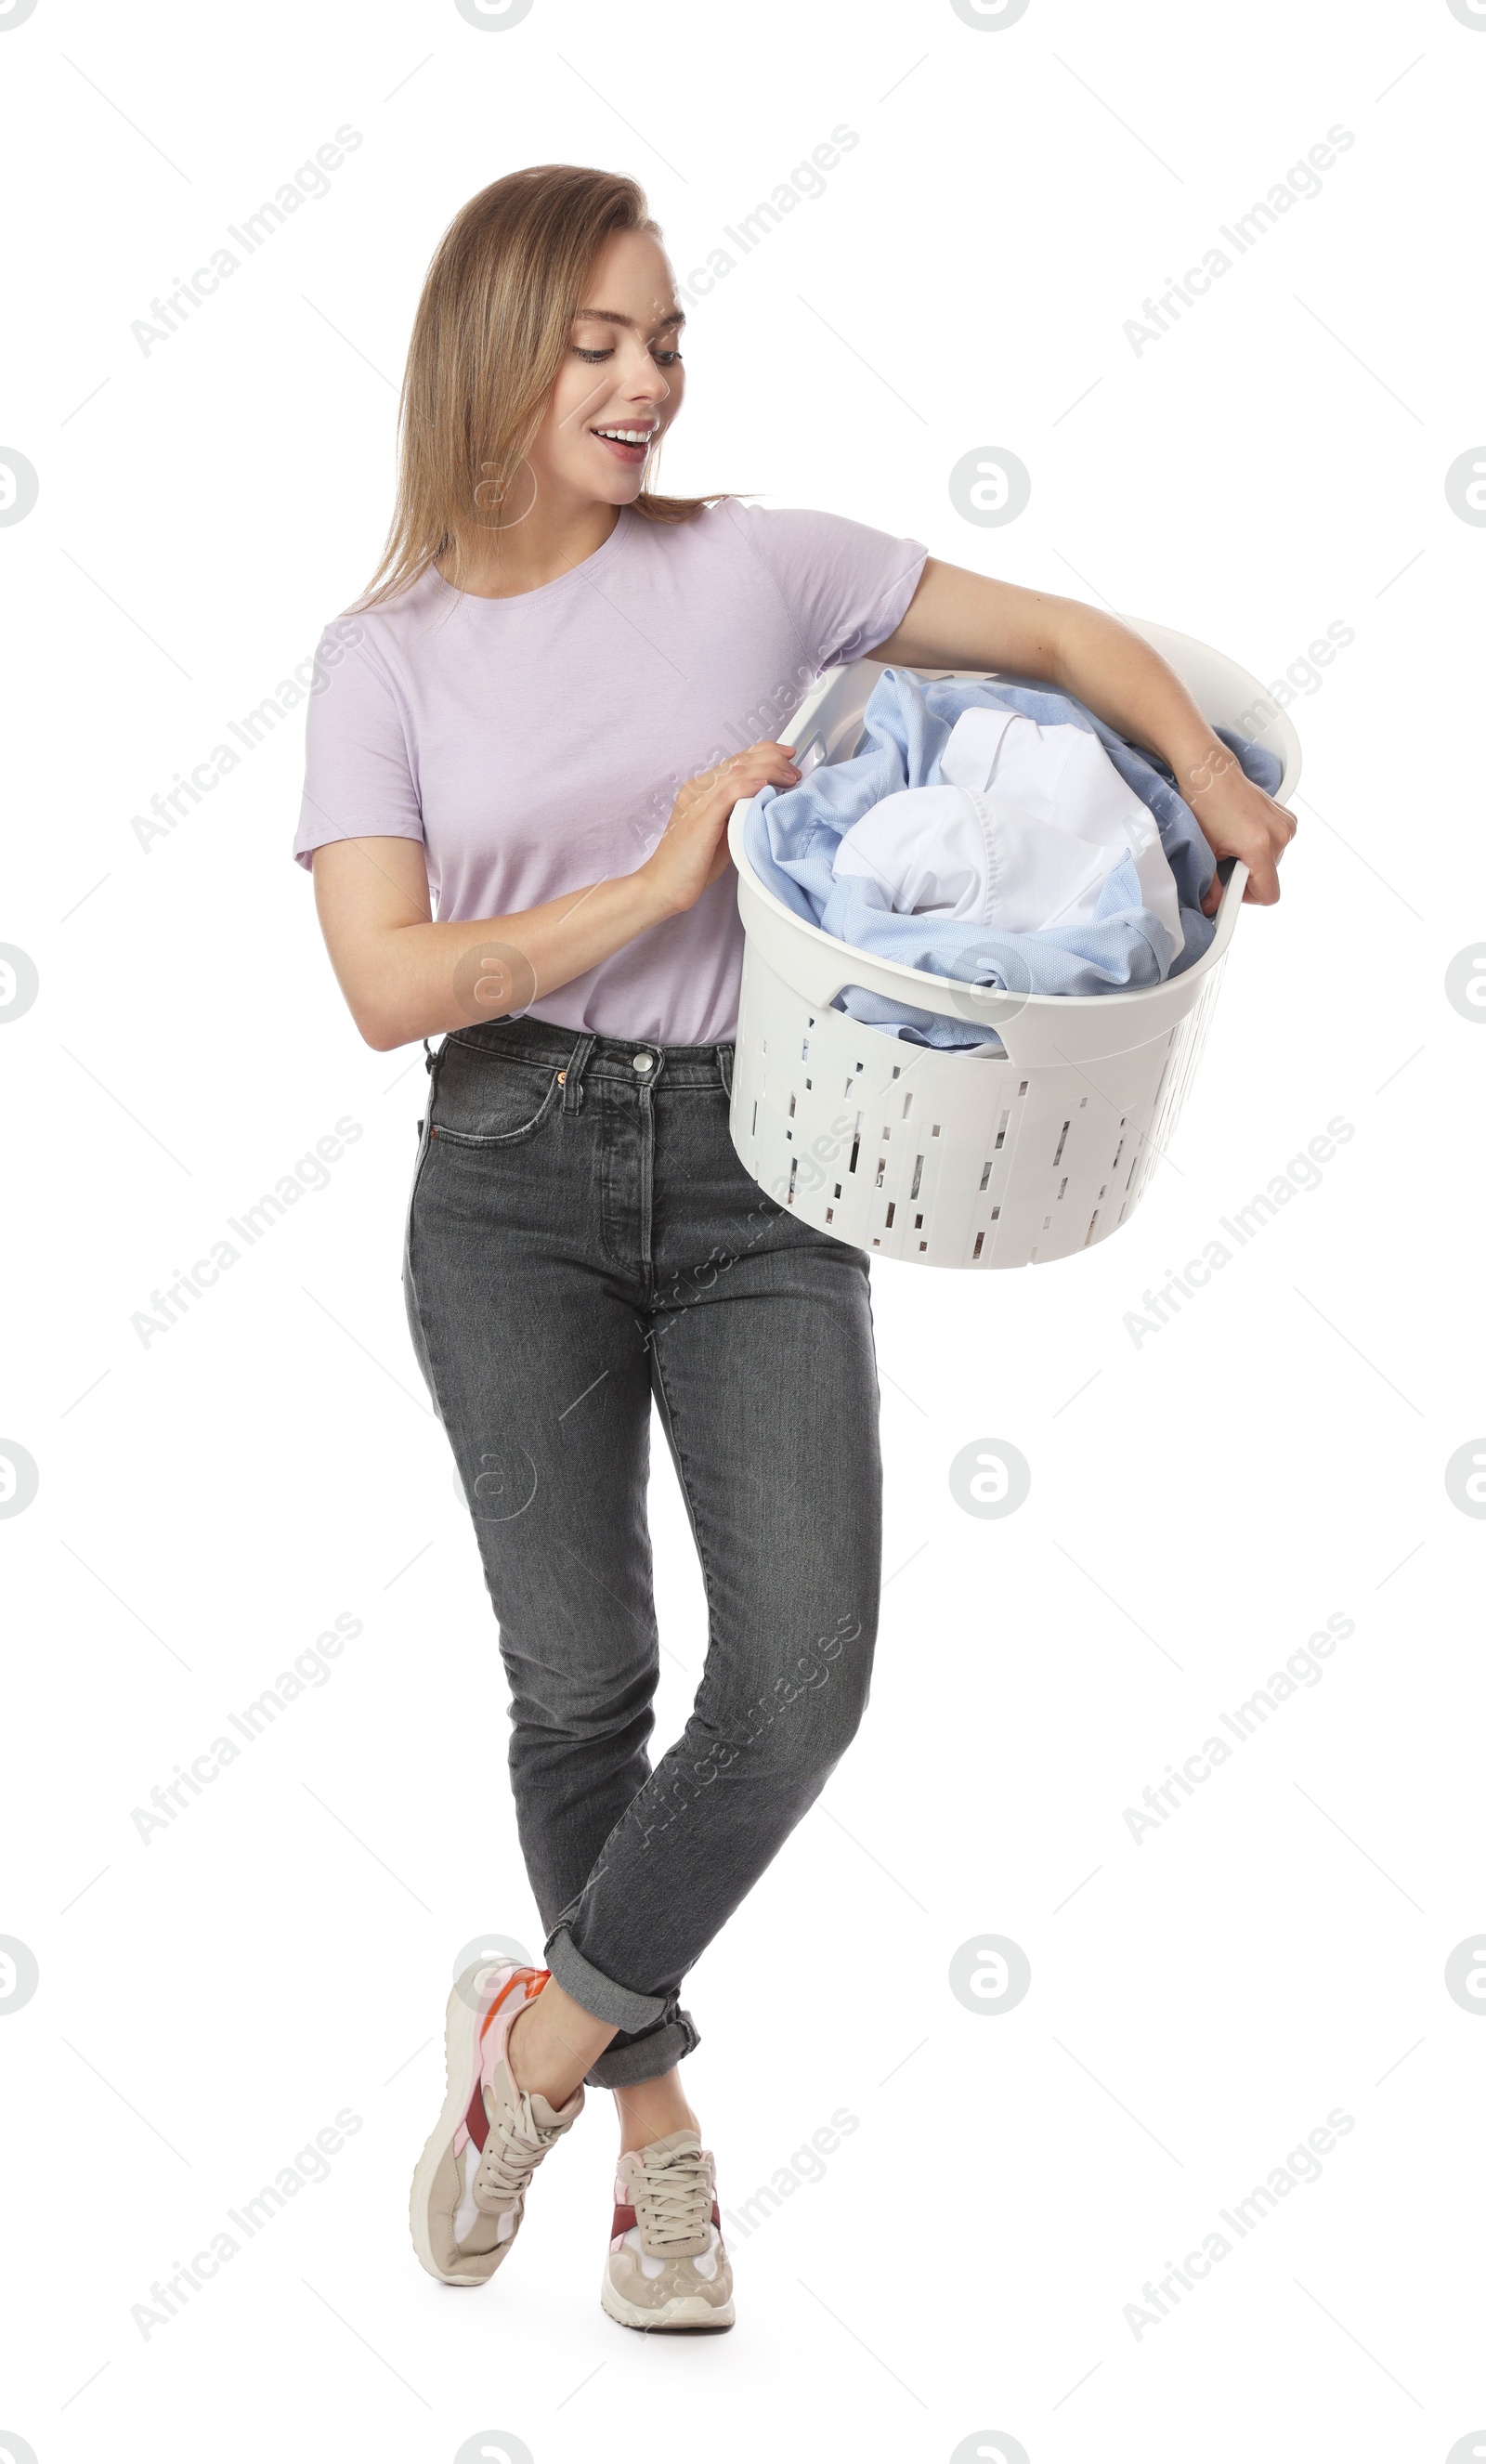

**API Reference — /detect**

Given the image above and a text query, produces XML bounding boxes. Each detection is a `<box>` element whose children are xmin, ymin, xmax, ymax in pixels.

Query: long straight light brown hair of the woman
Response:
<box><xmin>358</xmin><ymin>163</ymin><xmax>720</xmax><ymax>608</ymax></box>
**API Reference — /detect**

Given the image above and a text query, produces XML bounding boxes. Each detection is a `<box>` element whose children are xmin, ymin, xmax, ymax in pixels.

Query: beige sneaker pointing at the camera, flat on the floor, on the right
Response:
<box><xmin>599</xmin><ymin>2132</ymin><xmax>735</xmax><ymax>2333</ymax></box>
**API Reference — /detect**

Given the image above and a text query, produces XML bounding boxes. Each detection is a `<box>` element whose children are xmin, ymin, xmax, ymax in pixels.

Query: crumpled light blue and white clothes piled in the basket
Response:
<box><xmin>744</xmin><ymin>668</ymin><xmax>1282</xmax><ymax>1049</ymax></box>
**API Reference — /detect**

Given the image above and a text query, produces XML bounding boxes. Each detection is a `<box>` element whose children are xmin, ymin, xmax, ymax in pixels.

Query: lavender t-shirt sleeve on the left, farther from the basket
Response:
<box><xmin>293</xmin><ymin>621</ymin><xmax>424</xmax><ymax>870</ymax></box>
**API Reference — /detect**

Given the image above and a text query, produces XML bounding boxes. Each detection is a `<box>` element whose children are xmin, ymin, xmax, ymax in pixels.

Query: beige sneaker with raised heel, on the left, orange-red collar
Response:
<box><xmin>409</xmin><ymin>1959</ymin><xmax>584</xmax><ymax>2284</ymax></box>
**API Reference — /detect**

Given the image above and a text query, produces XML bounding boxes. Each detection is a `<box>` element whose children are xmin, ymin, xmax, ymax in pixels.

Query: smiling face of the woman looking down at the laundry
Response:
<box><xmin>528</xmin><ymin>231</ymin><xmax>683</xmax><ymax>519</ymax></box>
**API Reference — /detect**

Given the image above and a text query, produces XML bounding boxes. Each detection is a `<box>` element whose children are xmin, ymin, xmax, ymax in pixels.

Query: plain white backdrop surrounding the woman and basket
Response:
<box><xmin>0</xmin><ymin>0</ymin><xmax>1486</xmax><ymax>2464</ymax></box>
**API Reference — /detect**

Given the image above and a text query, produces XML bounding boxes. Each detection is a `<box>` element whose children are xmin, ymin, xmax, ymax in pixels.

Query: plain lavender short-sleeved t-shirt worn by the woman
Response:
<box><xmin>293</xmin><ymin>501</ymin><xmax>927</xmax><ymax>1045</ymax></box>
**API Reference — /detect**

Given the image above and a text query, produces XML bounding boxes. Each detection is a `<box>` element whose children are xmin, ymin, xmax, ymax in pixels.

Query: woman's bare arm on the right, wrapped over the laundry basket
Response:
<box><xmin>870</xmin><ymin>557</ymin><xmax>1297</xmax><ymax>914</ymax></box>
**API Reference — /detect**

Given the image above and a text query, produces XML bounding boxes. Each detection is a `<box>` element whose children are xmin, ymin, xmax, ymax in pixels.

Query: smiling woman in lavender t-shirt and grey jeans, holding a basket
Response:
<box><xmin>295</xmin><ymin>165</ymin><xmax>1294</xmax><ymax>2328</ymax></box>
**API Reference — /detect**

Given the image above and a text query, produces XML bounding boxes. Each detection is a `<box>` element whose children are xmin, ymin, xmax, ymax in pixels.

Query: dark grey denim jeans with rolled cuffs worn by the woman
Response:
<box><xmin>404</xmin><ymin>1018</ymin><xmax>882</xmax><ymax>2087</ymax></box>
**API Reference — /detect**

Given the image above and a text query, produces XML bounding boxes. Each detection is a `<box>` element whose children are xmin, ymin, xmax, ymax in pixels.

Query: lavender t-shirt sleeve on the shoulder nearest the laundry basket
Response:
<box><xmin>727</xmin><ymin>501</ymin><xmax>929</xmax><ymax>672</ymax></box>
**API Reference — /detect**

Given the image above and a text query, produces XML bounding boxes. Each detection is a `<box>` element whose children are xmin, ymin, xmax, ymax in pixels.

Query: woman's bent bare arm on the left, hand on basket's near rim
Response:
<box><xmin>313</xmin><ymin>724</ymin><xmax>799</xmax><ymax>1052</ymax></box>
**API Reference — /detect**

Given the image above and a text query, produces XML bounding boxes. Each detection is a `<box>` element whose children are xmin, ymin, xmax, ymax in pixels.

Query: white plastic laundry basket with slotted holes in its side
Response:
<box><xmin>727</xmin><ymin>616</ymin><xmax>1301</xmax><ymax>1267</ymax></box>
